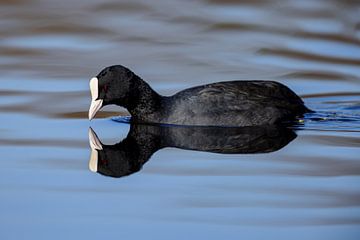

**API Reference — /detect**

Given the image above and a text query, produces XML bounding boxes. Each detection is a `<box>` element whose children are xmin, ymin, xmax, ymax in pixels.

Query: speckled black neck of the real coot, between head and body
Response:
<box><xmin>125</xmin><ymin>76</ymin><xmax>162</xmax><ymax>122</ymax></box>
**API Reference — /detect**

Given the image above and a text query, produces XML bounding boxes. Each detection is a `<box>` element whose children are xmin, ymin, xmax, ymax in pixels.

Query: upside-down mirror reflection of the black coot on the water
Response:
<box><xmin>89</xmin><ymin>124</ymin><xmax>296</xmax><ymax>177</ymax></box>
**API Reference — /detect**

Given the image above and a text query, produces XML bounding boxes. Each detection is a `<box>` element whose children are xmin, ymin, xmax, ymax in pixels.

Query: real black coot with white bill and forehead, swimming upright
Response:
<box><xmin>89</xmin><ymin>65</ymin><xmax>311</xmax><ymax>127</ymax></box>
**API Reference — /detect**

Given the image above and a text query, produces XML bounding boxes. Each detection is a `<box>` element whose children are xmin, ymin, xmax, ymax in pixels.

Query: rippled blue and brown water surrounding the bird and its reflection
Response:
<box><xmin>0</xmin><ymin>0</ymin><xmax>360</xmax><ymax>239</ymax></box>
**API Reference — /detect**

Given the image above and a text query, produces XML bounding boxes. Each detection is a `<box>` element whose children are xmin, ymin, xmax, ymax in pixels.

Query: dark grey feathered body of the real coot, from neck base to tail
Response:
<box><xmin>160</xmin><ymin>81</ymin><xmax>308</xmax><ymax>126</ymax></box>
